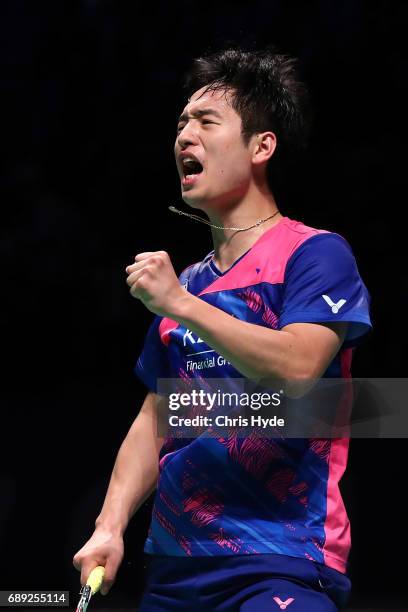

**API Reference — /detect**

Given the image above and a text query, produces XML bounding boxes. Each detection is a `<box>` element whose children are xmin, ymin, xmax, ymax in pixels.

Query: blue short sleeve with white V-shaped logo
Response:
<box><xmin>279</xmin><ymin>232</ymin><xmax>371</xmax><ymax>348</ymax></box>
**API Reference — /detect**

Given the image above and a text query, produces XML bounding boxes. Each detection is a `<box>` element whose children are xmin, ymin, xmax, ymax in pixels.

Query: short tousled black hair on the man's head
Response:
<box><xmin>183</xmin><ymin>46</ymin><xmax>312</xmax><ymax>191</ymax></box>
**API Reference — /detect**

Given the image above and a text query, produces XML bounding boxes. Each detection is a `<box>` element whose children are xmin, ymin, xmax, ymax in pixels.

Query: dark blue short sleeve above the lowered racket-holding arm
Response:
<box><xmin>134</xmin><ymin>316</ymin><xmax>170</xmax><ymax>393</ymax></box>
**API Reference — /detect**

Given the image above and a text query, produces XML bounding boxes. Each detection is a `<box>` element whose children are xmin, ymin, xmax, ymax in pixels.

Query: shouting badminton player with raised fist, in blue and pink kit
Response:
<box><xmin>74</xmin><ymin>45</ymin><xmax>370</xmax><ymax>612</ymax></box>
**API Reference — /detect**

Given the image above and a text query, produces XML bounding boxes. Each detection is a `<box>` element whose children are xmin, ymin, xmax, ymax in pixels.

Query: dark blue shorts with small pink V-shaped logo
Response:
<box><xmin>138</xmin><ymin>554</ymin><xmax>351</xmax><ymax>612</ymax></box>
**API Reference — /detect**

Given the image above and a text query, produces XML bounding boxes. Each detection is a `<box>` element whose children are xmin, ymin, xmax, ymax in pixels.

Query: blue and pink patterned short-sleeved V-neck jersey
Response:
<box><xmin>135</xmin><ymin>217</ymin><xmax>371</xmax><ymax>572</ymax></box>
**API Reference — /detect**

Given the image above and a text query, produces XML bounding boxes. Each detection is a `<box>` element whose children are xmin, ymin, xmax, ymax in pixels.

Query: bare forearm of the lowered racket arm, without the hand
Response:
<box><xmin>95</xmin><ymin>394</ymin><xmax>162</xmax><ymax>534</ymax></box>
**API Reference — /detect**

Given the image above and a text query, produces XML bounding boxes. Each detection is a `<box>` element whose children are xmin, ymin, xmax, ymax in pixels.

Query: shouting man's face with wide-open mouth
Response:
<box><xmin>174</xmin><ymin>87</ymin><xmax>252</xmax><ymax>208</ymax></box>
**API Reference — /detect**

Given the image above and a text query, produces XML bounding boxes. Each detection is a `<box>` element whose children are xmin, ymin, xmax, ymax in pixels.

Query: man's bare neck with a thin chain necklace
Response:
<box><xmin>207</xmin><ymin>191</ymin><xmax>282</xmax><ymax>271</ymax></box>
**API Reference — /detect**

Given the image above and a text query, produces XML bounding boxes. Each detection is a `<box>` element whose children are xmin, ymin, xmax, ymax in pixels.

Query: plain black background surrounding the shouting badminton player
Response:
<box><xmin>0</xmin><ymin>0</ymin><xmax>408</xmax><ymax>610</ymax></box>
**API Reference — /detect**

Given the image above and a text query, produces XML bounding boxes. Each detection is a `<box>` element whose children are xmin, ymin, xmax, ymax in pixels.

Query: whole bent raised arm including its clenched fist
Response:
<box><xmin>126</xmin><ymin>251</ymin><xmax>347</xmax><ymax>383</ymax></box>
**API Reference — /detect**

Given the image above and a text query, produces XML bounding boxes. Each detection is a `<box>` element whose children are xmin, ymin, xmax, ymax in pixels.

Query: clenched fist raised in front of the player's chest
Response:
<box><xmin>126</xmin><ymin>251</ymin><xmax>189</xmax><ymax>317</ymax></box>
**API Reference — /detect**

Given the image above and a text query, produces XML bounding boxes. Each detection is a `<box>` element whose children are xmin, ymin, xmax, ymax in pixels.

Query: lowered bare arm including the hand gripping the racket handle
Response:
<box><xmin>73</xmin><ymin>393</ymin><xmax>163</xmax><ymax>594</ymax></box>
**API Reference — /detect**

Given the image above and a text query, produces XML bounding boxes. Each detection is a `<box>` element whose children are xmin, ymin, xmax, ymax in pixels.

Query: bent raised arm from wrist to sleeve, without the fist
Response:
<box><xmin>173</xmin><ymin>296</ymin><xmax>347</xmax><ymax>382</ymax></box>
